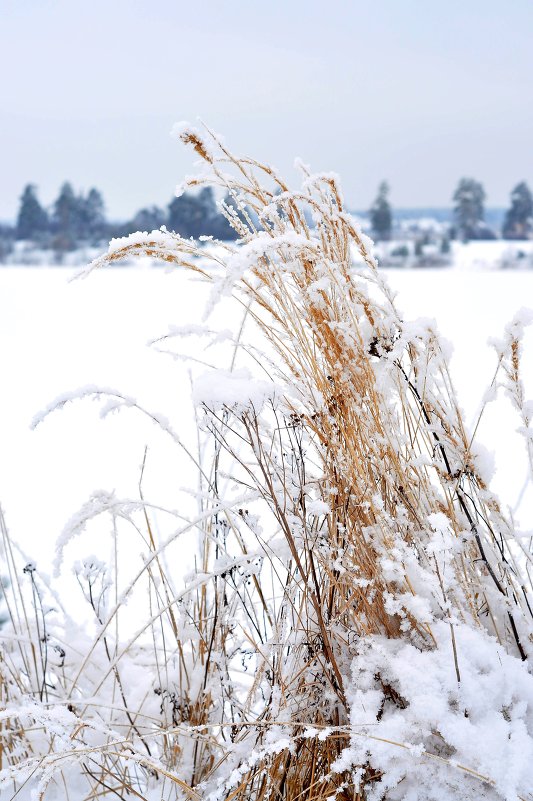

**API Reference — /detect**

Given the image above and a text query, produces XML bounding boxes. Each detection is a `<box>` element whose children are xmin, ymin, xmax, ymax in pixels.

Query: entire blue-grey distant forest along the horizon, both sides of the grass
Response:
<box><xmin>0</xmin><ymin>178</ymin><xmax>533</xmax><ymax>262</ymax></box>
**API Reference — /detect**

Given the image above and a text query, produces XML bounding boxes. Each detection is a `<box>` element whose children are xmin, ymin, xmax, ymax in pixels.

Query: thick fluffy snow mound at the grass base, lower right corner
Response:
<box><xmin>335</xmin><ymin>620</ymin><xmax>533</xmax><ymax>801</ymax></box>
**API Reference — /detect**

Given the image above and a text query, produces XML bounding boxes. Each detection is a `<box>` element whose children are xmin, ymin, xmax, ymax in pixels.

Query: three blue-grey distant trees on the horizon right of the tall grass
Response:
<box><xmin>368</xmin><ymin>178</ymin><xmax>533</xmax><ymax>242</ymax></box>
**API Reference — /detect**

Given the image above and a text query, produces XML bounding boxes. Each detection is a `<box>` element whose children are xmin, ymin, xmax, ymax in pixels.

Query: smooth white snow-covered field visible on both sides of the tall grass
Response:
<box><xmin>0</xmin><ymin>267</ymin><xmax>533</xmax><ymax>568</ymax></box>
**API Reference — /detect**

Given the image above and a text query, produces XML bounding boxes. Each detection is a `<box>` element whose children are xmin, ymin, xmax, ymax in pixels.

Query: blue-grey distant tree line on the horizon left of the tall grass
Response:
<box><xmin>6</xmin><ymin>181</ymin><xmax>236</xmax><ymax>253</ymax></box>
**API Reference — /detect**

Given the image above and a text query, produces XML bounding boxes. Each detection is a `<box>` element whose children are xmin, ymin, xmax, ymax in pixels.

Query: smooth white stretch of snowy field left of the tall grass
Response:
<box><xmin>0</xmin><ymin>268</ymin><xmax>210</xmax><ymax>570</ymax></box>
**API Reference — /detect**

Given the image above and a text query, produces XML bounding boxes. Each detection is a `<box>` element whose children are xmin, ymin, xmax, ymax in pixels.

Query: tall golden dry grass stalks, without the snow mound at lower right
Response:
<box><xmin>4</xmin><ymin>129</ymin><xmax>532</xmax><ymax>801</ymax></box>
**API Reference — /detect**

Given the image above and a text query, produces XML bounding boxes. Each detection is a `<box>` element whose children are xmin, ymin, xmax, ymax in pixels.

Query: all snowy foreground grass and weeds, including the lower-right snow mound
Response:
<box><xmin>0</xmin><ymin>127</ymin><xmax>533</xmax><ymax>801</ymax></box>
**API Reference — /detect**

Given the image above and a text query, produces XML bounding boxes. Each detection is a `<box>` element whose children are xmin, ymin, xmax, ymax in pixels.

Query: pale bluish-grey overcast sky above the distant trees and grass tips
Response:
<box><xmin>0</xmin><ymin>0</ymin><xmax>533</xmax><ymax>219</ymax></box>
